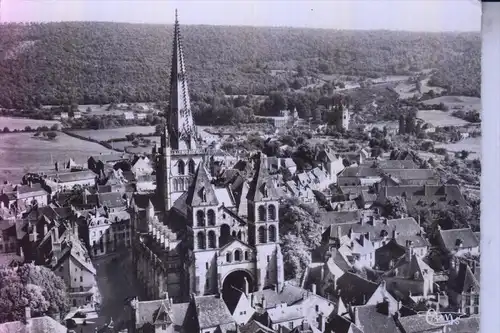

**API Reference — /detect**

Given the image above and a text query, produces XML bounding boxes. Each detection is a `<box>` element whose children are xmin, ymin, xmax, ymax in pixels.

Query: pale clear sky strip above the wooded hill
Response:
<box><xmin>0</xmin><ymin>0</ymin><xmax>481</xmax><ymax>32</ymax></box>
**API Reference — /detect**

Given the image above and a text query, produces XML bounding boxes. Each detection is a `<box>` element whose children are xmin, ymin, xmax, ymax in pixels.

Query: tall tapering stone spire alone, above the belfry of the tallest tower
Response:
<box><xmin>167</xmin><ymin>10</ymin><xmax>196</xmax><ymax>149</ymax></box>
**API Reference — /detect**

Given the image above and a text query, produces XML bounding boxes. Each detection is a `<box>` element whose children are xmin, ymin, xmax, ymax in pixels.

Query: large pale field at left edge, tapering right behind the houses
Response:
<box><xmin>0</xmin><ymin>133</ymin><xmax>113</xmax><ymax>182</ymax></box>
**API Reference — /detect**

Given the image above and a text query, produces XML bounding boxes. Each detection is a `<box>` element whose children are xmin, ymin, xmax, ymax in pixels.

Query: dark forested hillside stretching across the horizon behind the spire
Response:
<box><xmin>0</xmin><ymin>22</ymin><xmax>481</xmax><ymax>108</ymax></box>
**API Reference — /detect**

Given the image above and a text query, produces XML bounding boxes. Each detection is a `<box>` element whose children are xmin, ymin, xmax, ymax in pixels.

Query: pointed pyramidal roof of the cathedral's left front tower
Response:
<box><xmin>186</xmin><ymin>163</ymin><xmax>219</xmax><ymax>207</ymax></box>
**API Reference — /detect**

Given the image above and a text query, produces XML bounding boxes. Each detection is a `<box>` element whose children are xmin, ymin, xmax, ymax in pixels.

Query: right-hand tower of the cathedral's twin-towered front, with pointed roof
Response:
<box><xmin>247</xmin><ymin>153</ymin><xmax>284</xmax><ymax>290</ymax></box>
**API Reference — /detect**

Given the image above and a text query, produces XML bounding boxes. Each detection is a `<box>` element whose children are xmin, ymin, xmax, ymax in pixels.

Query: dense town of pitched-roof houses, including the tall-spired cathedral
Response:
<box><xmin>0</xmin><ymin>11</ymin><xmax>480</xmax><ymax>333</ymax></box>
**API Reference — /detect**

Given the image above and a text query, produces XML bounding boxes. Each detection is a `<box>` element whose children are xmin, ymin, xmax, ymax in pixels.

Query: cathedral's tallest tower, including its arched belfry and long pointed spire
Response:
<box><xmin>156</xmin><ymin>11</ymin><xmax>206</xmax><ymax>206</ymax></box>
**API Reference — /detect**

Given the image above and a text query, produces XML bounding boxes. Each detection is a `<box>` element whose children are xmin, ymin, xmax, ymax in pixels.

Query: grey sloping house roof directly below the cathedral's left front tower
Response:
<box><xmin>194</xmin><ymin>295</ymin><xmax>234</xmax><ymax>329</ymax></box>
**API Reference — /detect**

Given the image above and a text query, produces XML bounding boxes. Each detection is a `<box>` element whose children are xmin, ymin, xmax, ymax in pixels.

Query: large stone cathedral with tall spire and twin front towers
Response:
<box><xmin>131</xmin><ymin>15</ymin><xmax>284</xmax><ymax>302</ymax></box>
